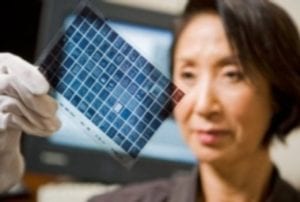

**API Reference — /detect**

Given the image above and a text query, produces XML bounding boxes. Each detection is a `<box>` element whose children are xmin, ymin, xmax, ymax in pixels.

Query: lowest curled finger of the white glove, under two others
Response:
<box><xmin>0</xmin><ymin>95</ymin><xmax>60</xmax><ymax>135</ymax></box>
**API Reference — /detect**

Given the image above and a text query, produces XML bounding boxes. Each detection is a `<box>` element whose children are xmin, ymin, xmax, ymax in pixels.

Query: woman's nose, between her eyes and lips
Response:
<box><xmin>192</xmin><ymin>79</ymin><xmax>221</xmax><ymax>119</ymax></box>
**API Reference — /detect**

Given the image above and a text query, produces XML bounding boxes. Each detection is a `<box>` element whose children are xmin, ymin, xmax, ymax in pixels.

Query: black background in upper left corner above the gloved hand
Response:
<box><xmin>0</xmin><ymin>0</ymin><xmax>42</xmax><ymax>63</ymax></box>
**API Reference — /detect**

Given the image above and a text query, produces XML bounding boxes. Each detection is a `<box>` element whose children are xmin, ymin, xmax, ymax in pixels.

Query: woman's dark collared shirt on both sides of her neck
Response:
<box><xmin>89</xmin><ymin>169</ymin><xmax>300</xmax><ymax>202</ymax></box>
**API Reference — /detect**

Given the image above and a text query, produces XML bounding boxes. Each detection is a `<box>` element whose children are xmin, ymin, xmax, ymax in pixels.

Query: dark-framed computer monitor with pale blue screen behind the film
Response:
<box><xmin>23</xmin><ymin>0</ymin><xmax>195</xmax><ymax>183</ymax></box>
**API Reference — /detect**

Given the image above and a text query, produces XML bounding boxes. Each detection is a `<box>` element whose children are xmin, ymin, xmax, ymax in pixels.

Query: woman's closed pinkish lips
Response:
<box><xmin>196</xmin><ymin>130</ymin><xmax>229</xmax><ymax>145</ymax></box>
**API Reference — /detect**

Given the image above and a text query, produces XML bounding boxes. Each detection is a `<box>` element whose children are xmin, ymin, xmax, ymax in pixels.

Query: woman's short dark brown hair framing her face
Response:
<box><xmin>171</xmin><ymin>0</ymin><xmax>300</xmax><ymax>145</ymax></box>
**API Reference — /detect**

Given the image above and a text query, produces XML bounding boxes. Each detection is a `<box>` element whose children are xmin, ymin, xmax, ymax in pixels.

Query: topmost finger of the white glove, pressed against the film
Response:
<box><xmin>0</xmin><ymin>53</ymin><xmax>50</xmax><ymax>95</ymax></box>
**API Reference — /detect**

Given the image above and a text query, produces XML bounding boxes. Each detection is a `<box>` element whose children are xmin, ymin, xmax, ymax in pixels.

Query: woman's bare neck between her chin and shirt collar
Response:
<box><xmin>199</xmin><ymin>151</ymin><xmax>272</xmax><ymax>202</ymax></box>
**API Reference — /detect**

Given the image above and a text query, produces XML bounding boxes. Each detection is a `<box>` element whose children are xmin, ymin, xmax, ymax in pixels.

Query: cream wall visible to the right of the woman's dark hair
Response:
<box><xmin>271</xmin><ymin>0</ymin><xmax>300</xmax><ymax>189</ymax></box>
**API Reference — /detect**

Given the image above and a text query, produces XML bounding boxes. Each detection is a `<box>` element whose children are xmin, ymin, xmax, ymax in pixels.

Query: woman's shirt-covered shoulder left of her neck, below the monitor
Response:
<box><xmin>89</xmin><ymin>170</ymin><xmax>196</xmax><ymax>202</ymax></box>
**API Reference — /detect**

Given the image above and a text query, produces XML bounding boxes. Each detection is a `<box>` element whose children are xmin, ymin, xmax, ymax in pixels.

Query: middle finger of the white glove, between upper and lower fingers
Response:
<box><xmin>0</xmin><ymin>74</ymin><xmax>57</xmax><ymax>118</ymax></box>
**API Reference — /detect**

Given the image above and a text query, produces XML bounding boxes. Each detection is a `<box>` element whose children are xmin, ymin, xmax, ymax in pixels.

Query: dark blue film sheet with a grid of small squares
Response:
<box><xmin>40</xmin><ymin>6</ymin><xmax>183</xmax><ymax>158</ymax></box>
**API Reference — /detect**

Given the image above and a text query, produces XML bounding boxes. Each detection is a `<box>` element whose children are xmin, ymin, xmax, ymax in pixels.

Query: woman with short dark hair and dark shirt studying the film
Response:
<box><xmin>91</xmin><ymin>0</ymin><xmax>300</xmax><ymax>202</ymax></box>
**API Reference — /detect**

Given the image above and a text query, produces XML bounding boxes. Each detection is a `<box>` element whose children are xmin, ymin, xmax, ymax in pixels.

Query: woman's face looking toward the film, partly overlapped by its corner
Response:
<box><xmin>173</xmin><ymin>13</ymin><xmax>273</xmax><ymax>162</ymax></box>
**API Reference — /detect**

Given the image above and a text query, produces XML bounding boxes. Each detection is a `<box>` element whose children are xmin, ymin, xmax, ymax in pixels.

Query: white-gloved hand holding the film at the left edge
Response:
<box><xmin>0</xmin><ymin>53</ymin><xmax>60</xmax><ymax>192</ymax></box>
